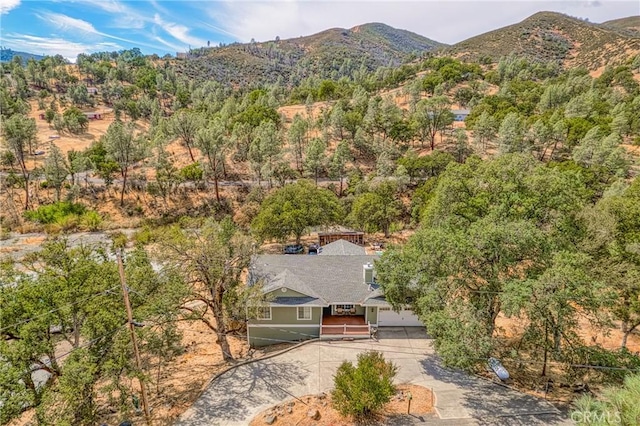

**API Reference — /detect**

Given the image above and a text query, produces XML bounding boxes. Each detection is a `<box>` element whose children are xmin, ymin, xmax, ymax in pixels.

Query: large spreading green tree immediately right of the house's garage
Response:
<box><xmin>376</xmin><ymin>154</ymin><xmax>587</xmax><ymax>368</ymax></box>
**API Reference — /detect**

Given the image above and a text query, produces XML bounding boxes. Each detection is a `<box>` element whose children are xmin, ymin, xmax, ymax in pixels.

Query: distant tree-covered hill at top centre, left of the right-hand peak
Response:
<box><xmin>176</xmin><ymin>23</ymin><xmax>443</xmax><ymax>85</ymax></box>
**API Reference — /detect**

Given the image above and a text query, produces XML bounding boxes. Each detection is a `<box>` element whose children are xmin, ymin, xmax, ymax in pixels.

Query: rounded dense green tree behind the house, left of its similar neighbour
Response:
<box><xmin>251</xmin><ymin>180</ymin><xmax>343</xmax><ymax>243</ymax></box>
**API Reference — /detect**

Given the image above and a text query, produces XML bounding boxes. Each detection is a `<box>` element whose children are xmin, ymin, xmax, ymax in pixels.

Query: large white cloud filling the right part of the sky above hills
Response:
<box><xmin>210</xmin><ymin>0</ymin><xmax>638</xmax><ymax>43</ymax></box>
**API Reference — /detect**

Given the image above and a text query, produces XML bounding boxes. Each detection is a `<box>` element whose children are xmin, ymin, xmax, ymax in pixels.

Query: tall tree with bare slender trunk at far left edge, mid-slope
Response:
<box><xmin>2</xmin><ymin>114</ymin><xmax>38</xmax><ymax>210</ymax></box>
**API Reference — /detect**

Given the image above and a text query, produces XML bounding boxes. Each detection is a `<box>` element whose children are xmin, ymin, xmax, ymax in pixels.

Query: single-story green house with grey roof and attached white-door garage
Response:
<box><xmin>247</xmin><ymin>241</ymin><xmax>422</xmax><ymax>347</ymax></box>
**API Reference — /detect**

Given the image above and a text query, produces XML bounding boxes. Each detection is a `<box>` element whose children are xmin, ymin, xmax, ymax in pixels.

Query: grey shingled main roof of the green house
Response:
<box><xmin>251</xmin><ymin>255</ymin><xmax>380</xmax><ymax>306</ymax></box>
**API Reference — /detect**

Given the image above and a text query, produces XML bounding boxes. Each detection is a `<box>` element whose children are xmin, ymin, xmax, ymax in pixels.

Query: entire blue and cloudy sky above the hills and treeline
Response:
<box><xmin>0</xmin><ymin>0</ymin><xmax>640</xmax><ymax>61</ymax></box>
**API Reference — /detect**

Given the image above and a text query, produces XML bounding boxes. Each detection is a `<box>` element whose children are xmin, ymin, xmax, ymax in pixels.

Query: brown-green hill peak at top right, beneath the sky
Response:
<box><xmin>444</xmin><ymin>12</ymin><xmax>640</xmax><ymax>70</ymax></box>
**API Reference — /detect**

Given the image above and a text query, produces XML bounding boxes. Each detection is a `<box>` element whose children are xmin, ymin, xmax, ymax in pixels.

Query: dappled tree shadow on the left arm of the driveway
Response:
<box><xmin>175</xmin><ymin>360</ymin><xmax>311</xmax><ymax>426</ymax></box>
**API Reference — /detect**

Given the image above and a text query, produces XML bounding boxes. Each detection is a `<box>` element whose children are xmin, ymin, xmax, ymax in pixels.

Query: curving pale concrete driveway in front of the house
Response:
<box><xmin>176</xmin><ymin>327</ymin><xmax>573</xmax><ymax>426</ymax></box>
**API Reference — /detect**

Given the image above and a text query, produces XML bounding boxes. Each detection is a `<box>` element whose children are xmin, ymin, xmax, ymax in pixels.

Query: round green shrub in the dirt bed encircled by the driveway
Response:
<box><xmin>332</xmin><ymin>351</ymin><xmax>397</xmax><ymax>418</ymax></box>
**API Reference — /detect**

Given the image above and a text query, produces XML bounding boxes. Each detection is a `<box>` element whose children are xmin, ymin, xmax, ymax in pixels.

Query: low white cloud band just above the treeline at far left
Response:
<box><xmin>2</xmin><ymin>34</ymin><xmax>122</xmax><ymax>62</ymax></box>
